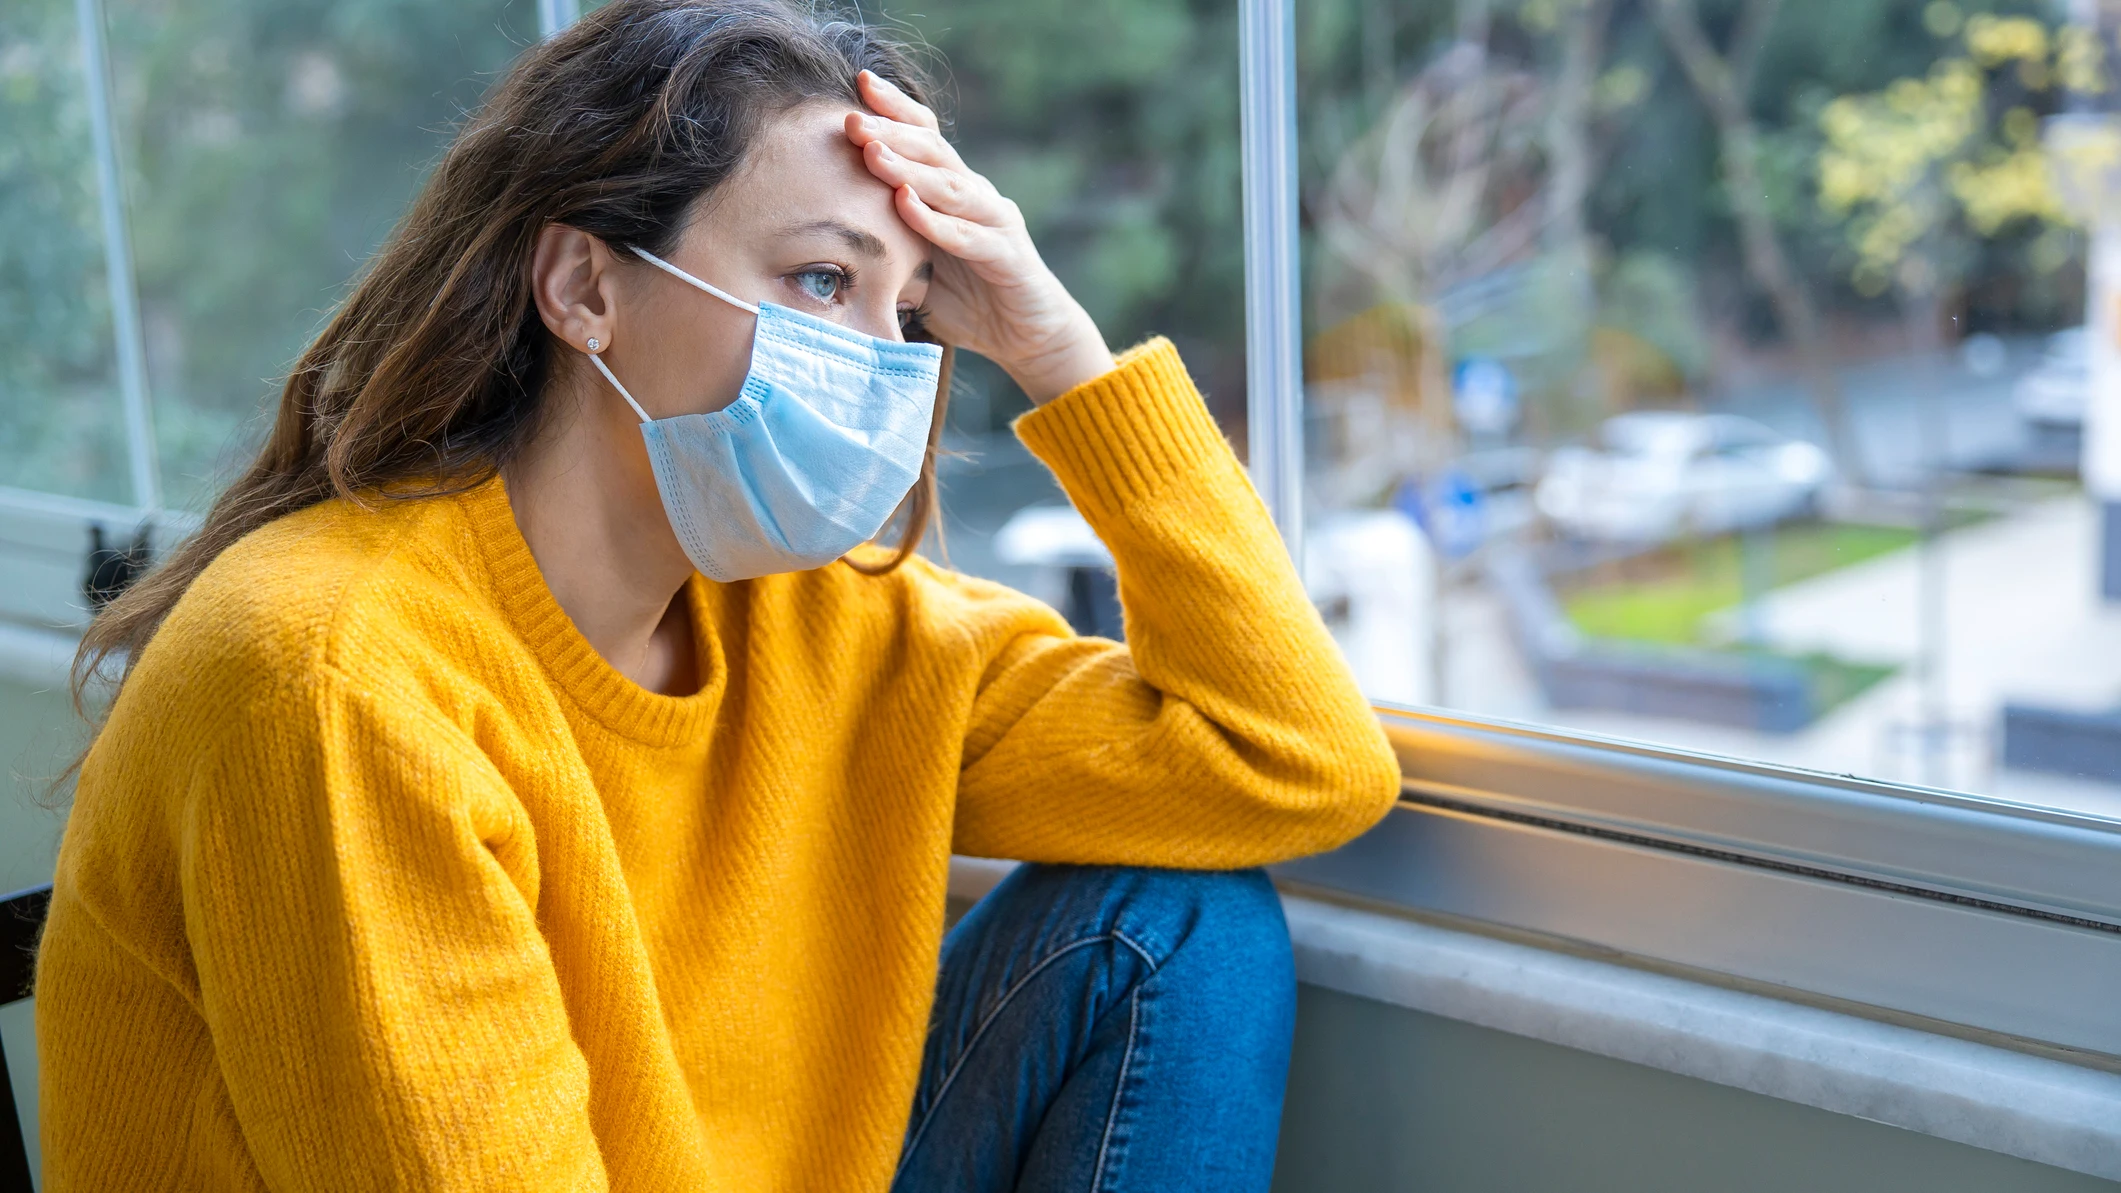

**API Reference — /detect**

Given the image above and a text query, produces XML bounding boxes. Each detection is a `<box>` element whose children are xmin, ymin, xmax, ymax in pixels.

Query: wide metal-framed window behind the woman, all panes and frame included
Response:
<box><xmin>0</xmin><ymin>0</ymin><xmax>2121</xmax><ymax>1055</ymax></box>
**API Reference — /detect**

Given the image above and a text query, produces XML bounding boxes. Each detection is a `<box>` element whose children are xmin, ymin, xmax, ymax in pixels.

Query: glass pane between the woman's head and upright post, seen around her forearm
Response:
<box><xmin>889</xmin><ymin>0</ymin><xmax>1245</xmax><ymax>611</ymax></box>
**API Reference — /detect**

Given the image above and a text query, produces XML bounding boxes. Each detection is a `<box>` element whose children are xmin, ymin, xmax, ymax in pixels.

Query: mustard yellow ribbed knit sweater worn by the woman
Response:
<box><xmin>36</xmin><ymin>342</ymin><xmax>1398</xmax><ymax>1193</ymax></box>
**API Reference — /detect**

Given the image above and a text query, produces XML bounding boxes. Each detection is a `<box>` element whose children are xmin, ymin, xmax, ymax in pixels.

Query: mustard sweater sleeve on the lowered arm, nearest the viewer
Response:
<box><xmin>176</xmin><ymin>671</ymin><xmax>607</xmax><ymax>1191</ymax></box>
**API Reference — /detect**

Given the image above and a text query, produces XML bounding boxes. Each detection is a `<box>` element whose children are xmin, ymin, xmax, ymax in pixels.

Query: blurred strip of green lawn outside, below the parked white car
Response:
<box><xmin>1559</xmin><ymin>522</ymin><xmax>1920</xmax><ymax>645</ymax></box>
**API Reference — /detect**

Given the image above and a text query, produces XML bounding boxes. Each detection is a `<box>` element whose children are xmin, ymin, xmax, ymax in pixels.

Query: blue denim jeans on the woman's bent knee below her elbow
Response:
<box><xmin>893</xmin><ymin>866</ymin><xmax>1296</xmax><ymax>1193</ymax></box>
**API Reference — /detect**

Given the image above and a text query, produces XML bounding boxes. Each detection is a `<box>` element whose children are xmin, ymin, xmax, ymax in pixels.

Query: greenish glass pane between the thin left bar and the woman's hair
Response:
<box><xmin>104</xmin><ymin>0</ymin><xmax>537</xmax><ymax>507</ymax></box>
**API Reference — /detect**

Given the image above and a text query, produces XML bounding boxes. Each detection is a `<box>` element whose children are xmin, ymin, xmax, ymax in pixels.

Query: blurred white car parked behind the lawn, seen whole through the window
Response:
<box><xmin>1533</xmin><ymin>410</ymin><xmax>1833</xmax><ymax>543</ymax></box>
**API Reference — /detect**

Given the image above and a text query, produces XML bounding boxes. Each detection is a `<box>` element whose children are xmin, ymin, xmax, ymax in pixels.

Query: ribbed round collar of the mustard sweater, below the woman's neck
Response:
<box><xmin>458</xmin><ymin>476</ymin><xmax>730</xmax><ymax>745</ymax></box>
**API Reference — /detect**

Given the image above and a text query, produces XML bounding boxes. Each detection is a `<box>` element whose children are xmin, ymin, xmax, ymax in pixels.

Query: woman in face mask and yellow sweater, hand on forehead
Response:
<box><xmin>36</xmin><ymin>0</ymin><xmax>1398</xmax><ymax>1191</ymax></box>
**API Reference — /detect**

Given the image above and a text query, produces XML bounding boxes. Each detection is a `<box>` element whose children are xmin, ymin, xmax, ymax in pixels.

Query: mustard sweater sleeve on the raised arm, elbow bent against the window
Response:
<box><xmin>954</xmin><ymin>340</ymin><xmax>1400</xmax><ymax>868</ymax></box>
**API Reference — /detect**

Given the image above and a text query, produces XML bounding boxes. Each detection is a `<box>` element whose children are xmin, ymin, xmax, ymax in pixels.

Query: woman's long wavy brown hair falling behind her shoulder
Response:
<box><xmin>74</xmin><ymin>0</ymin><xmax>952</xmax><ymax>707</ymax></box>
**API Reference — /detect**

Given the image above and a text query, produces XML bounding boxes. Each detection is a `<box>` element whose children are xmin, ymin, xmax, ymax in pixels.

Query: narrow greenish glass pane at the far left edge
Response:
<box><xmin>0</xmin><ymin>0</ymin><xmax>132</xmax><ymax>501</ymax></box>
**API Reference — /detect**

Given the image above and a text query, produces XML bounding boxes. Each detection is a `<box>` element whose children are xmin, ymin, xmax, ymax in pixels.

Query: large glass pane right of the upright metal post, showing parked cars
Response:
<box><xmin>1298</xmin><ymin>0</ymin><xmax>2121</xmax><ymax>815</ymax></box>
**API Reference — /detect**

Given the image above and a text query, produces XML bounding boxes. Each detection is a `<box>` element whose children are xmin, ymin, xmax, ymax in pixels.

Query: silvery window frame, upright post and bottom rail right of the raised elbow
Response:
<box><xmin>1239</xmin><ymin>0</ymin><xmax>2121</xmax><ymax>1059</ymax></box>
